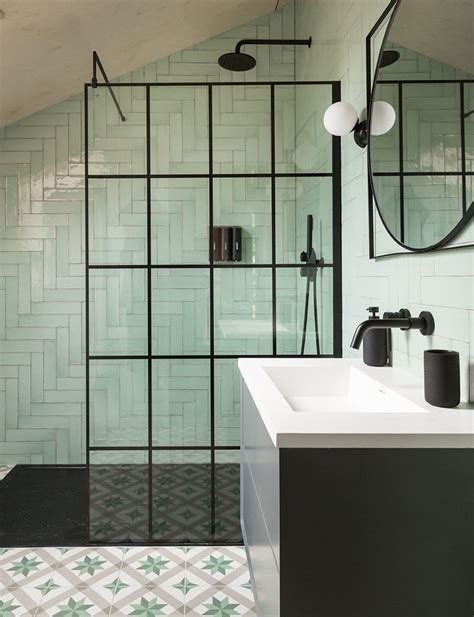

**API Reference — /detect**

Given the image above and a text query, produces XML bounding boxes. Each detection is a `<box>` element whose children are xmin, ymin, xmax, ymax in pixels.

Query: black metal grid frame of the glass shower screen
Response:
<box><xmin>84</xmin><ymin>76</ymin><xmax>342</xmax><ymax>543</ymax></box>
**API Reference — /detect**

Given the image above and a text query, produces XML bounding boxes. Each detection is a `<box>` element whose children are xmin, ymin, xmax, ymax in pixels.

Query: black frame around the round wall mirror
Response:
<box><xmin>365</xmin><ymin>0</ymin><xmax>474</xmax><ymax>259</ymax></box>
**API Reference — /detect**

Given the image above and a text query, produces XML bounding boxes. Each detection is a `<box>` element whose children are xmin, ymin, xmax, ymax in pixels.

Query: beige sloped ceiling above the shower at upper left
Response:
<box><xmin>0</xmin><ymin>0</ymin><xmax>286</xmax><ymax>126</ymax></box>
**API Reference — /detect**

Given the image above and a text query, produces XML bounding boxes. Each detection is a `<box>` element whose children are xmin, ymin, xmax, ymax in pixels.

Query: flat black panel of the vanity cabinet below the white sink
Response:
<box><xmin>280</xmin><ymin>449</ymin><xmax>474</xmax><ymax>617</ymax></box>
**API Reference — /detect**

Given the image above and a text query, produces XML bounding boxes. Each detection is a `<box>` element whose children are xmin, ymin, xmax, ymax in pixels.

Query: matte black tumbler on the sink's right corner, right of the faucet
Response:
<box><xmin>424</xmin><ymin>349</ymin><xmax>460</xmax><ymax>407</ymax></box>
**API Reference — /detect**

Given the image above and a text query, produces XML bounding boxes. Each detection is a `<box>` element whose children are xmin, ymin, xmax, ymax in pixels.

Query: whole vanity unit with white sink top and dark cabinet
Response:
<box><xmin>239</xmin><ymin>358</ymin><xmax>474</xmax><ymax>617</ymax></box>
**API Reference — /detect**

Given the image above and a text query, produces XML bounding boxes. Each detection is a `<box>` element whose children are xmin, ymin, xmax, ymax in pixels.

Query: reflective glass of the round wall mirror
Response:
<box><xmin>368</xmin><ymin>0</ymin><xmax>474</xmax><ymax>251</ymax></box>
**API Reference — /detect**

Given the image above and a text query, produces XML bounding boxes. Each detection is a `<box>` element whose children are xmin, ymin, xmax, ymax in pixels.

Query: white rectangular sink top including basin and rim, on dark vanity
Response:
<box><xmin>239</xmin><ymin>358</ymin><xmax>474</xmax><ymax>448</ymax></box>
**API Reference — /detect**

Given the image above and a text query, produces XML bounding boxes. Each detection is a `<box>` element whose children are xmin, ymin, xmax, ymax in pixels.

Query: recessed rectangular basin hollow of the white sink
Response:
<box><xmin>263</xmin><ymin>364</ymin><xmax>427</xmax><ymax>413</ymax></box>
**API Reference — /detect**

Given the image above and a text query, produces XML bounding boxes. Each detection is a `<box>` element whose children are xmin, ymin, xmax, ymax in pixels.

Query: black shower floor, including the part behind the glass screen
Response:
<box><xmin>0</xmin><ymin>463</ymin><xmax>242</xmax><ymax>547</ymax></box>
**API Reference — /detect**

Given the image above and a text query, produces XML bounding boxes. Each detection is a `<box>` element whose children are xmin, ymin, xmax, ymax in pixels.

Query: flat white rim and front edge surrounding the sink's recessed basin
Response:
<box><xmin>238</xmin><ymin>357</ymin><xmax>474</xmax><ymax>448</ymax></box>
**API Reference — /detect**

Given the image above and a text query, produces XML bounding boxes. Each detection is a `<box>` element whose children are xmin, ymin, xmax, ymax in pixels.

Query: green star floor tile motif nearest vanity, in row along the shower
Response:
<box><xmin>186</xmin><ymin>546</ymin><xmax>248</xmax><ymax>587</ymax></box>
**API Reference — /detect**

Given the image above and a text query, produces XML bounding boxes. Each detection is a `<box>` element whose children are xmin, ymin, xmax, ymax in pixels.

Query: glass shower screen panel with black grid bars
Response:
<box><xmin>84</xmin><ymin>81</ymin><xmax>342</xmax><ymax>544</ymax></box>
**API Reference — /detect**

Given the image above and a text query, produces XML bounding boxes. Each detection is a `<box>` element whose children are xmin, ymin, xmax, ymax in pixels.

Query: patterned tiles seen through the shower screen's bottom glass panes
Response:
<box><xmin>89</xmin><ymin>463</ymin><xmax>241</xmax><ymax>544</ymax></box>
